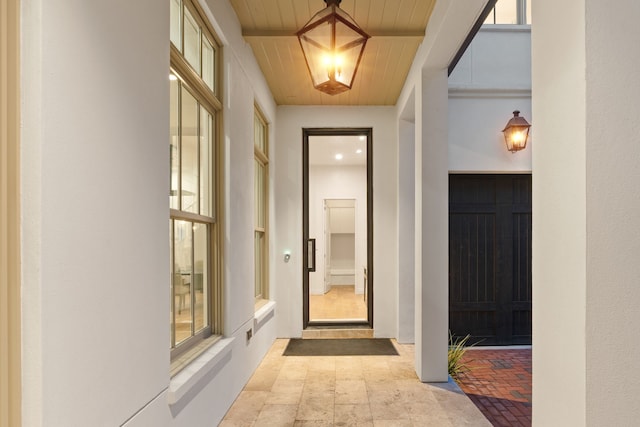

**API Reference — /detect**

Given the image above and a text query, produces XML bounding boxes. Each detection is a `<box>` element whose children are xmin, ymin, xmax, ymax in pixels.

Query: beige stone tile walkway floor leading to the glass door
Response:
<box><xmin>220</xmin><ymin>339</ymin><xmax>491</xmax><ymax>427</ymax></box>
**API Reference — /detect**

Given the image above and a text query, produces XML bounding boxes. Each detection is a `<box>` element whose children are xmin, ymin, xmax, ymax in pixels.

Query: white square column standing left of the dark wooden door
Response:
<box><xmin>415</xmin><ymin>69</ymin><xmax>449</xmax><ymax>382</ymax></box>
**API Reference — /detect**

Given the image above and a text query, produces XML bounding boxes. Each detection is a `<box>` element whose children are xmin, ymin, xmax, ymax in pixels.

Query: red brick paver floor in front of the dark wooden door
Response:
<box><xmin>458</xmin><ymin>349</ymin><xmax>531</xmax><ymax>427</ymax></box>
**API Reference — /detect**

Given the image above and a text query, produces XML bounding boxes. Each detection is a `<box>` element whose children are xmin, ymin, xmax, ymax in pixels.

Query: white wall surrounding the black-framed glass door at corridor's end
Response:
<box><xmin>274</xmin><ymin>106</ymin><xmax>398</xmax><ymax>337</ymax></box>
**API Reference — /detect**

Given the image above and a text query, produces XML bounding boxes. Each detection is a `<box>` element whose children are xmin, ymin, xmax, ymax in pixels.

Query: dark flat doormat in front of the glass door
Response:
<box><xmin>283</xmin><ymin>338</ymin><xmax>398</xmax><ymax>356</ymax></box>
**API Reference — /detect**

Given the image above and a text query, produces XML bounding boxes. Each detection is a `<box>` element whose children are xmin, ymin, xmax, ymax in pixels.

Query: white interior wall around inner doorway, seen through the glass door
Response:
<box><xmin>309</xmin><ymin>166</ymin><xmax>367</xmax><ymax>295</ymax></box>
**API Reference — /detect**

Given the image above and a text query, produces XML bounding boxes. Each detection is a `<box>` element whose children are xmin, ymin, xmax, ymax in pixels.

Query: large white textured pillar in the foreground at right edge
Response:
<box><xmin>532</xmin><ymin>0</ymin><xmax>640</xmax><ymax>426</ymax></box>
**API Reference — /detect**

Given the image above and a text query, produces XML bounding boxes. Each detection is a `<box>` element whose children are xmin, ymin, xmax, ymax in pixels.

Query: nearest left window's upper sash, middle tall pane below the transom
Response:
<box><xmin>180</xmin><ymin>90</ymin><xmax>199</xmax><ymax>213</ymax></box>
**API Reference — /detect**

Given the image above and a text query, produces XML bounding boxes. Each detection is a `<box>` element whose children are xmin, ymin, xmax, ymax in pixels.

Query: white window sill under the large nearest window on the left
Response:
<box><xmin>167</xmin><ymin>337</ymin><xmax>235</xmax><ymax>405</ymax></box>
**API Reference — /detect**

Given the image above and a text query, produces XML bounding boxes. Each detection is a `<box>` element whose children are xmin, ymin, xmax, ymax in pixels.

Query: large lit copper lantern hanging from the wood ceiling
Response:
<box><xmin>296</xmin><ymin>0</ymin><xmax>370</xmax><ymax>95</ymax></box>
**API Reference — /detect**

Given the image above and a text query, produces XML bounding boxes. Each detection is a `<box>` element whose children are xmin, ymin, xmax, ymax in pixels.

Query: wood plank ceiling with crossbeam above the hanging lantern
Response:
<box><xmin>230</xmin><ymin>0</ymin><xmax>436</xmax><ymax>105</ymax></box>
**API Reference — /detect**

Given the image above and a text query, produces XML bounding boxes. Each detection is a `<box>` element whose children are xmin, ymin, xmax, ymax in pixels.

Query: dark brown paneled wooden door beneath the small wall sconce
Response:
<box><xmin>449</xmin><ymin>175</ymin><xmax>531</xmax><ymax>345</ymax></box>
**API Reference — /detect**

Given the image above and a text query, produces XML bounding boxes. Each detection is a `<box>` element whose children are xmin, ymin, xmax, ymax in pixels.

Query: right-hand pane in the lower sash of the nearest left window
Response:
<box><xmin>193</xmin><ymin>223</ymin><xmax>209</xmax><ymax>333</ymax></box>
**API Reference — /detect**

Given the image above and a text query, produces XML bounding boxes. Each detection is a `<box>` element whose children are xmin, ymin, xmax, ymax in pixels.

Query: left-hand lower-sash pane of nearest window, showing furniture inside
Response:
<box><xmin>173</xmin><ymin>220</ymin><xmax>193</xmax><ymax>345</ymax></box>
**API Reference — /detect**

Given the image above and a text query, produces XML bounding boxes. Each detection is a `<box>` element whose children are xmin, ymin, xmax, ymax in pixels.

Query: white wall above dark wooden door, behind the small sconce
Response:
<box><xmin>449</xmin><ymin>25</ymin><xmax>535</xmax><ymax>173</ymax></box>
